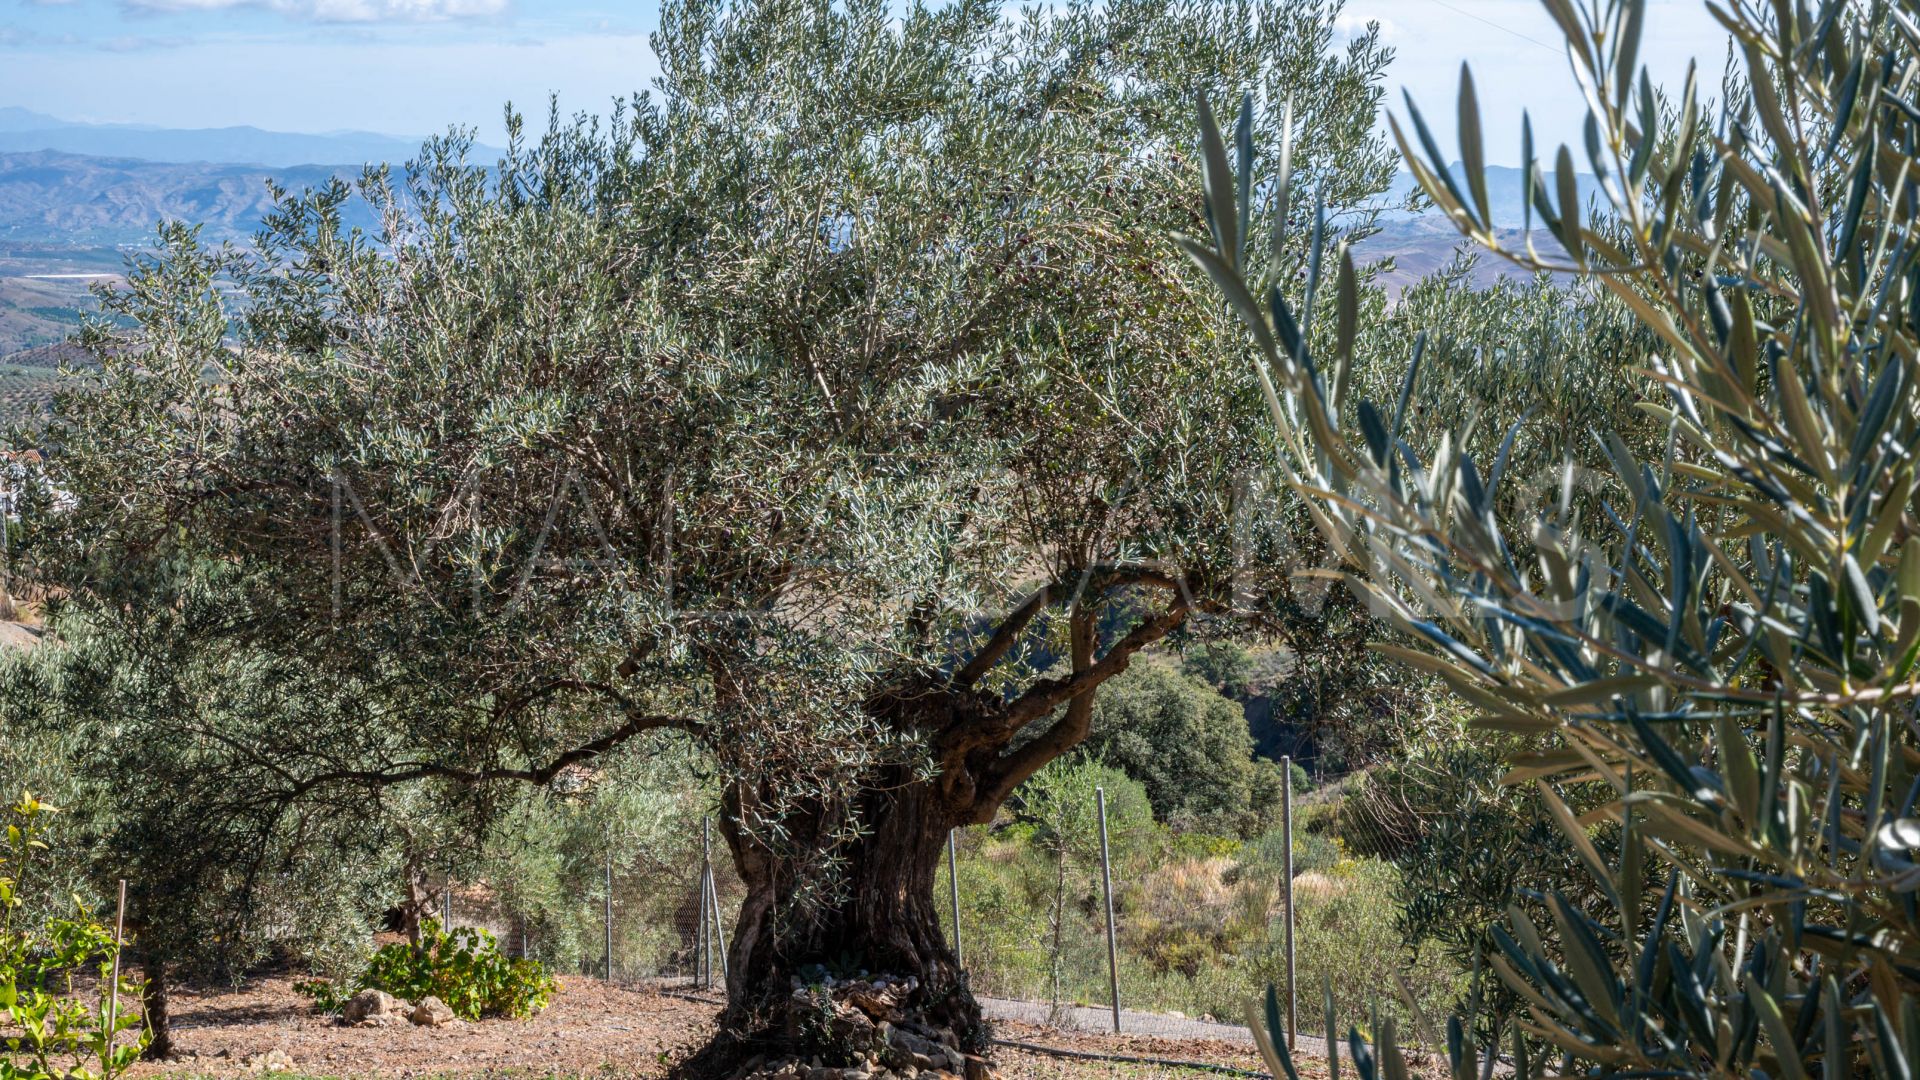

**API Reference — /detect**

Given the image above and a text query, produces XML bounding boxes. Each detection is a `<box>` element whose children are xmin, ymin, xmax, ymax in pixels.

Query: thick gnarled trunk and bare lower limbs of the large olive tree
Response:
<box><xmin>689</xmin><ymin>590</ymin><xmax>1187</xmax><ymax>1072</ymax></box>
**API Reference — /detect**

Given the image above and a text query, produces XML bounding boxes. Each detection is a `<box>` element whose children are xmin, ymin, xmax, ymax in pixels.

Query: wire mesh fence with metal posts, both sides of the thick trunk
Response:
<box><xmin>451</xmin><ymin>760</ymin><xmax>1467</xmax><ymax>1049</ymax></box>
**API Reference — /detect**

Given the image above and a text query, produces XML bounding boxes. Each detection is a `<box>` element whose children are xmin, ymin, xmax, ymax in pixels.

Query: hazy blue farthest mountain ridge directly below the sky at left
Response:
<box><xmin>0</xmin><ymin>106</ymin><xmax>499</xmax><ymax>169</ymax></box>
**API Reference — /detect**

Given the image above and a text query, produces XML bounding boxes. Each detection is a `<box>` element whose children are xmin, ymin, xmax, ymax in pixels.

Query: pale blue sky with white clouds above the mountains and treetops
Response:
<box><xmin>0</xmin><ymin>0</ymin><xmax>1726</xmax><ymax>163</ymax></box>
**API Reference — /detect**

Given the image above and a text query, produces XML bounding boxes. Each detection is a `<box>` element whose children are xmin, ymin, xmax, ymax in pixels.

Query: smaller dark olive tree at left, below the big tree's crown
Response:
<box><xmin>0</xmin><ymin>575</ymin><xmax>401</xmax><ymax>1059</ymax></box>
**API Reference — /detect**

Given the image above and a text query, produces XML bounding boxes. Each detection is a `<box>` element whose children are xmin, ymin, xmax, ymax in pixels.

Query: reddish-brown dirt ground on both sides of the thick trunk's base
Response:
<box><xmin>134</xmin><ymin>976</ymin><xmax>1305</xmax><ymax>1080</ymax></box>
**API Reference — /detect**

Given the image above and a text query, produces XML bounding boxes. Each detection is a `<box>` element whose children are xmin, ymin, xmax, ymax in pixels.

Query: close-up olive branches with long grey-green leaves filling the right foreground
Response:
<box><xmin>1188</xmin><ymin>0</ymin><xmax>1920</xmax><ymax>1076</ymax></box>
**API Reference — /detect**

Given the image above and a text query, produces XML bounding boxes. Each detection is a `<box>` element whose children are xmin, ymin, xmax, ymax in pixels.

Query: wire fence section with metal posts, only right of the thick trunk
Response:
<box><xmin>939</xmin><ymin>753</ymin><xmax>1467</xmax><ymax>1043</ymax></box>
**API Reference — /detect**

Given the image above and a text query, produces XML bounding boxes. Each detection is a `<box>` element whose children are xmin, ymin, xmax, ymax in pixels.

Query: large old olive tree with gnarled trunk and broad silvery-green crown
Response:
<box><xmin>36</xmin><ymin>0</ymin><xmax>1390</xmax><ymax>1038</ymax></box>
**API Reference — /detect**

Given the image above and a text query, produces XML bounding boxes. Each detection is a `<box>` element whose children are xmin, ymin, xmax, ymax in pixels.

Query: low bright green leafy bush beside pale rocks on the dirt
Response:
<box><xmin>296</xmin><ymin>919</ymin><xmax>557</xmax><ymax>1020</ymax></box>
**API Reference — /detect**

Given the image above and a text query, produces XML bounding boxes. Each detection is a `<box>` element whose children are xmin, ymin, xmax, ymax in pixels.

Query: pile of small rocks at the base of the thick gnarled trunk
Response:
<box><xmin>741</xmin><ymin>974</ymin><xmax>991</xmax><ymax>1080</ymax></box>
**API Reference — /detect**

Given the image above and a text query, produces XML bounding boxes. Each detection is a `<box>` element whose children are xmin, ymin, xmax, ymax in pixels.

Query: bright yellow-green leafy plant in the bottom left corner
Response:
<box><xmin>0</xmin><ymin>794</ymin><xmax>148</xmax><ymax>1080</ymax></box>
